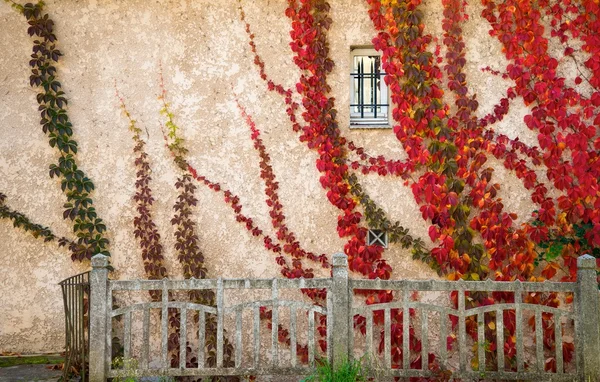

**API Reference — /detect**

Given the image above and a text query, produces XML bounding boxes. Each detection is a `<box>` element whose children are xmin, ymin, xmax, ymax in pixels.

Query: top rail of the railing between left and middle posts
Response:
<box><xmin>109</xmin><ymin>278</ymin><xmax>332</xmax><ymax>291</ymax></box>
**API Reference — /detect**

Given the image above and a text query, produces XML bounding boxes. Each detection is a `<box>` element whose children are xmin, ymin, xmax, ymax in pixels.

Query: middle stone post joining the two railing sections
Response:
<box><xmin>331</xmin><ymin>253</ymin><xmax>352</xmax><ymax>369</ymax></box>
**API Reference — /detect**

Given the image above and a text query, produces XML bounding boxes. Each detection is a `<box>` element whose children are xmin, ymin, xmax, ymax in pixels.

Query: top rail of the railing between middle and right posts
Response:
<box><xmin>349</xmin><ymin>279</ymin><xmax>577</xmax><ymax>292</ymax></box>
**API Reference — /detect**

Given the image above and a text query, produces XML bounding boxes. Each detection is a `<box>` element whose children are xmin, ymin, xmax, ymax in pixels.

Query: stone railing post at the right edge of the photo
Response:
<box><xmin>577</xmin><ymin>255</ymin><xmax>600</xmax><ymax>382</ymax></box>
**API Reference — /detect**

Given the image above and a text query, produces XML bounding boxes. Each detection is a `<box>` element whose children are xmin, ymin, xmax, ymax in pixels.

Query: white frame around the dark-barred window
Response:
<box><xmin>349</xmin><ymin>47</ymin><xmax>391</xmax><ymax>128</ymax></box>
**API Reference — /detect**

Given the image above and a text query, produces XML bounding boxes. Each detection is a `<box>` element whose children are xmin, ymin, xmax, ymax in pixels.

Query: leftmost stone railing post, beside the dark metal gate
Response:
<box><xmin>89</xmin><ymin>254</ymin><xmax>108</xmax><ymax>382</ymax></box>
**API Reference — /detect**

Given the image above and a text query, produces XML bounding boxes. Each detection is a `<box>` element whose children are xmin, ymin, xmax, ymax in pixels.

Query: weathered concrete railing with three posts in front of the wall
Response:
<box><xmin>89</xmin><ymin>254</ymin><xmax>600</xmax><ymax>382</ymax></box>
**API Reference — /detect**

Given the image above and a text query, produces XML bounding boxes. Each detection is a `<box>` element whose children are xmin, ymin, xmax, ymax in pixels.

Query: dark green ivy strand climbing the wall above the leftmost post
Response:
<box><xmin>19</xmin><ymin>1</ymin><xmax>110</xmax><ymax>261</ymax></box>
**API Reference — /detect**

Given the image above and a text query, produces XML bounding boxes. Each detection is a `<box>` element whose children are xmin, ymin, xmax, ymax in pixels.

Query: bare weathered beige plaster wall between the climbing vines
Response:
<box><xmin>0</xmin><ymin>0</ymin><xmax>534</xmax><ymax>352</ymax></box>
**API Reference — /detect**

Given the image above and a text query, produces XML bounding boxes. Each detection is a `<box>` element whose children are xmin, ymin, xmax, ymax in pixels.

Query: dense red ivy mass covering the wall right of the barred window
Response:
<box><xmin>369</xmin><ymin>0</ymin><xmax>600</xmax><ymax>370</ymax></box>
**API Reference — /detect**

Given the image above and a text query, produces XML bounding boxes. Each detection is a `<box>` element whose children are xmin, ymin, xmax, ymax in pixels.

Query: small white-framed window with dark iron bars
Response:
<box><xmin>350</xmin><ymin>49</ymin><xmax>390</xmax><ymax>127</ymax></box>
